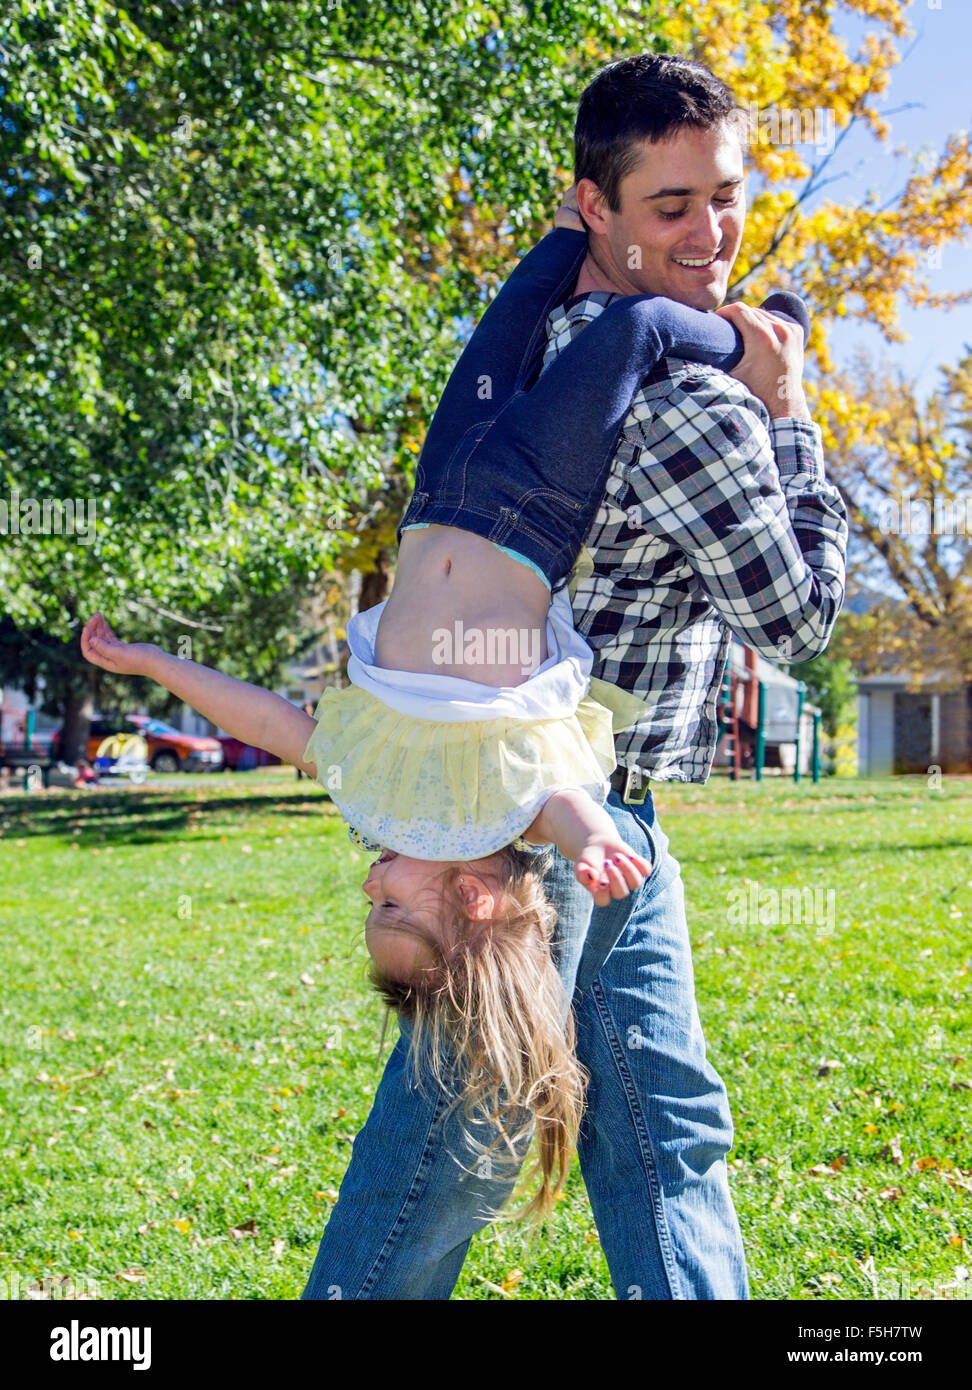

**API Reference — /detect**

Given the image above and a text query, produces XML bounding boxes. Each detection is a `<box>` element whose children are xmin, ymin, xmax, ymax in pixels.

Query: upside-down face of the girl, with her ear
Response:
<box><xmin>362</xmin><ymin>849</ymin><xmax>496</xmax><ymax>983</ymax></box>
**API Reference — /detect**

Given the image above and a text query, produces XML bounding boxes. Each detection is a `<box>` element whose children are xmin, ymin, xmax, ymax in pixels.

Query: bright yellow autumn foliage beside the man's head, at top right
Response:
<box><xmin>662</xmin><ymin>0</ymin><xmax>972</xmax><ymax>361</ymax></box>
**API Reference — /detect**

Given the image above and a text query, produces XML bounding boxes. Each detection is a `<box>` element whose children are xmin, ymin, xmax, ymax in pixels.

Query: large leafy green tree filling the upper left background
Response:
<box><xmin>0</xmin><ymin>0</ymin><xmax>659</xmax><ymax>761</ymax></box>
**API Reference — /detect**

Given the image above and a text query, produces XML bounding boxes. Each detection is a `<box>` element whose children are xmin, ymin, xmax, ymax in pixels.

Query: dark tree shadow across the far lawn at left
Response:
<box><xmin>0</xmin><ymin>787</ymin><xmax>334</xmax><ymax>845</ymax></box>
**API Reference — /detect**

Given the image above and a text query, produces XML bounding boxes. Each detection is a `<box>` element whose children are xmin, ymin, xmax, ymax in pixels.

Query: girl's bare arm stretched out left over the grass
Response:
<box><xmin>81</xmin><ymin>613</ymin><xmax>317</xmax><ymax>777</ymax></box>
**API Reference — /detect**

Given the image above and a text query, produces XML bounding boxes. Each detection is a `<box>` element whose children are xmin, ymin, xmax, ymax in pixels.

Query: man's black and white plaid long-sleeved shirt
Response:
<box><xmin>541</xmin><ymin>291</ymin><xmax>847</xmax><ymax>783</ymax></box>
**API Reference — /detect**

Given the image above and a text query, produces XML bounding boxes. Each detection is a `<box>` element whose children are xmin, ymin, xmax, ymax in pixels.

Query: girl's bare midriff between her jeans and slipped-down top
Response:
<box><xmin>375</xmin><ymin>525</ymin><xmax>551</xmax><ymax>685</ymax></box>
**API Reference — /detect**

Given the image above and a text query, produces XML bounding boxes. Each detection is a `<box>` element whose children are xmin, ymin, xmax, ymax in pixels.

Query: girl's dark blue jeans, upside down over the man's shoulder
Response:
<box><xmin>398</xmin><ymin>228</ymin><xmax>743</xmax><ymax>589</ymax></box>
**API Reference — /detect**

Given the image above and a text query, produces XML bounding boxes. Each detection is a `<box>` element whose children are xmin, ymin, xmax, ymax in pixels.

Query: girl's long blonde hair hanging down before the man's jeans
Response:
<box><xmin>368</xmin><ymin>845</ymin><xmax>590</xmax><ymax>1225</ymax></box>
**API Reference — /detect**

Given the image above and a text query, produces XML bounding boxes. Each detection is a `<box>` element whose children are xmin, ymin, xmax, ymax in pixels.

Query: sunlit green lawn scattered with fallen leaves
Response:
<box><xmin>0</xmin><ymin>769</ymin><xmax>972</xmax><ymax>1300</ymax></box>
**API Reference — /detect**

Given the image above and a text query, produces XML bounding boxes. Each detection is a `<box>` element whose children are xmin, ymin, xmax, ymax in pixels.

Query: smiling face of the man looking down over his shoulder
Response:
<box><xmin>577</xmin><ymin>122</ymin><xmax>745</xmax><ymax>310</ymax></box>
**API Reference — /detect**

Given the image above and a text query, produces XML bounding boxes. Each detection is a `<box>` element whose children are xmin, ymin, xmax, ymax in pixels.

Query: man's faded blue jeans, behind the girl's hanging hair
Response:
<box><xmin>302</xmin><ymin>791</ymin><xmax>750</xmax><ymax>1300</ymax></box>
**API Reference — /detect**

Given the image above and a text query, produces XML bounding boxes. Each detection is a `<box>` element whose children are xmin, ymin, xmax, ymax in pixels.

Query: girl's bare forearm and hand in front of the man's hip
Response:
<box><xmin>523</xmin><ymin>787</ymin><xmax>651</xmax><ymax>908</ymax></box>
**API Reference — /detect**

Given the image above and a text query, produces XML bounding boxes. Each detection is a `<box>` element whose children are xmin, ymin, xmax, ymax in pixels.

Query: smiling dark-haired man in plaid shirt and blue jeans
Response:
<box><xmin>303</xmin><ymin>56</ymin><xmax>847</xmax><ymax>1298</ymax></box>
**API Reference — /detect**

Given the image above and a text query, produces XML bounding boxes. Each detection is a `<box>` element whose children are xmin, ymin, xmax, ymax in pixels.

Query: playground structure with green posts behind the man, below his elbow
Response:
<box><xmin>719</xmin><ymin>646</ymin><xmax>822</xmax><ymax>781</ymax></box>
